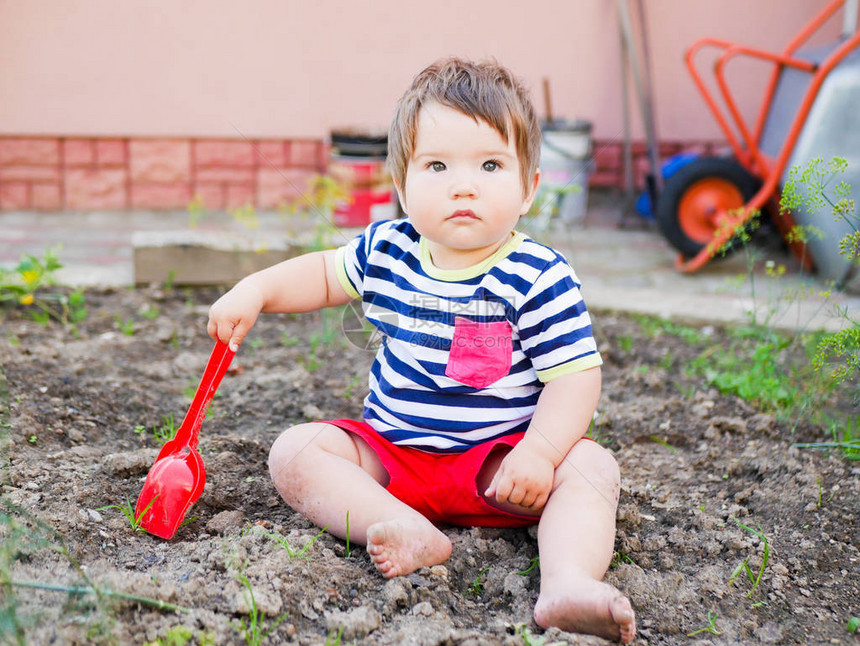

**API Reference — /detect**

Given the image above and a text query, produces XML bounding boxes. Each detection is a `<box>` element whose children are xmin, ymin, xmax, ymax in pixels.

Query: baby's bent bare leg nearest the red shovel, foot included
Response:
<box><xmin>269</xmin><ymin>423</ymin><xmax>451</xmax><ymax>577</ymax></box>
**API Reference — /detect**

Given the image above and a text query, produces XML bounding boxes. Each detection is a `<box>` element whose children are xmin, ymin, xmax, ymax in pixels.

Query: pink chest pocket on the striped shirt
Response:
<box><xmin>445</xmin><ymin>316</ymin><xmax>512</xmax><ymax>388</ymax></box>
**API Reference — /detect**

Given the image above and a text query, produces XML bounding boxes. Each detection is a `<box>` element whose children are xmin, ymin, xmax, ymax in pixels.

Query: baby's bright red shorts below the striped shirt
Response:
<box><xmin>327</xmin><ymin>419</ymin><xmax>540</xmax><ymax>527</ymax></box>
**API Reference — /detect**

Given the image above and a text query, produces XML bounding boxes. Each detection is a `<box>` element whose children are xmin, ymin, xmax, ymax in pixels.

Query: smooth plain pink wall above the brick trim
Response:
<box><xmin>0</xmin><ymin>0</ymin><xmax>840</xmax><ymax>141</ymax></box>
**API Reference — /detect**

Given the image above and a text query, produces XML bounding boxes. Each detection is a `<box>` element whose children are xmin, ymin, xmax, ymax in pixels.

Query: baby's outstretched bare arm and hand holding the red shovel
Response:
<box><xmin>206</xmin><ymin>249</ymin><xmax>351</xmax><ymax>351</ymax></box>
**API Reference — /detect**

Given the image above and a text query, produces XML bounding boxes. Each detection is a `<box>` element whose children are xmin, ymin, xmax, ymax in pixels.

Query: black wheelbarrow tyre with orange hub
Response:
<box><xmin>656</xmin><ymin>157</ymin><xmax>761</xmax><ymax>258</ymax></box>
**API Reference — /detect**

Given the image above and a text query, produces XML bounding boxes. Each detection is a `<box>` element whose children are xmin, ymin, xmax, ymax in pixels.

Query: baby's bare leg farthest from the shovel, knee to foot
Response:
<box><xmin>478</xmin><ymin>440</ymin><xmax>636</xmax><ymax>643</ymax></box>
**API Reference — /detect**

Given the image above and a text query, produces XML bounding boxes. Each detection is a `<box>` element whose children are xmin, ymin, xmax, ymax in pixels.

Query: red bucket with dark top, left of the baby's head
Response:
<box><xmin>327</xmin><ymin>131</ymin><xmax>397</xmax><ymax>227</ymax></box>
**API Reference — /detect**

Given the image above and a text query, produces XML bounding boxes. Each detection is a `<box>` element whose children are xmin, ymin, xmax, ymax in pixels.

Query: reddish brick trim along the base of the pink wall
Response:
<box><xmin>0</xmin><ymin>135</ymin><xmax>724</xmax><ymax>211</ymax></box>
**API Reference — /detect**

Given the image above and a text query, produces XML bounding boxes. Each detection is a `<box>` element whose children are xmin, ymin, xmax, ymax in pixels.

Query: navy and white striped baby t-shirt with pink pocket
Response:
<box><xmin>336</xmin><ymin>219</ymin><xmax>602</xmax><ymax>453</ymax></box>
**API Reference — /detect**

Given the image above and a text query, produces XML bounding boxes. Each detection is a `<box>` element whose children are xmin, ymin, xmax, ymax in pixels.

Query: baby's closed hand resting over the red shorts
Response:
<box><xmin>484</xmin><ymin>440</ymin><xmax>555</xmax><ymax>511</ymax></box>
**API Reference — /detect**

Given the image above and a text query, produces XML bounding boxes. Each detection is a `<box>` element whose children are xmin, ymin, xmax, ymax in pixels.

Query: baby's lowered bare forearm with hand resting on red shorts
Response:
<box><xmin>484</xmin><ymin>367</ymin><xmax>601</xmax><ymax>511</ymax></box>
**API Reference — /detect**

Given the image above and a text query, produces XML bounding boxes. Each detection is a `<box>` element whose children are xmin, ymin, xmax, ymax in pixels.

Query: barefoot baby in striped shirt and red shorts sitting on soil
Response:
<box><xmin>208</xmin><ymin>59</ymin><xmax>636</xmax><ymax>643</ymax></box>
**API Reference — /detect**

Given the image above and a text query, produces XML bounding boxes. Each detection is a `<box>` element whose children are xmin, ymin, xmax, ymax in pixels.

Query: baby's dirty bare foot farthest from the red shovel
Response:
<box><xmin>534</xmin><ymin>577</ymin><xmax>636</xmax><ymax>644</ymax></box>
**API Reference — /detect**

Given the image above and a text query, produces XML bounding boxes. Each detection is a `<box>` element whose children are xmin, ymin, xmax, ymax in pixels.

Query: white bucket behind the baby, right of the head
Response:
<box><xmin>539</xmin><ymin>120</ymin><xmax>591</xmax><ymax>224</ymax></box>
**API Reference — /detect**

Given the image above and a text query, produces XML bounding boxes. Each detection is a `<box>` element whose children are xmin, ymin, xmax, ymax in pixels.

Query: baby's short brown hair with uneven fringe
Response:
<box><xmin>388</xmin><ymin>58</ymin><xmax>541</xmax><ymax>200</ymax></box>
